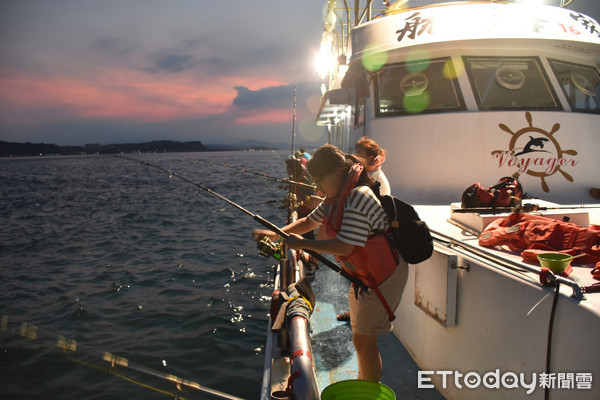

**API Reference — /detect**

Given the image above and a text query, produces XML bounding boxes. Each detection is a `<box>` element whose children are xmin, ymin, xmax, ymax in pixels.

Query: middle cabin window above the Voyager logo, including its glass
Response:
<box><xmin>463</xmin><ymin>57</ymin><xmax>562</xmax><ymax>111</ymax></box>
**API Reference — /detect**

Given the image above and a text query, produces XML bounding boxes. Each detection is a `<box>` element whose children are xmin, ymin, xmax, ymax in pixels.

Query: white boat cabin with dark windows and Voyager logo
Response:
<box><xmin>317</xmin><ymin>1</ymin><xmax>600</xmax><ymax>204</ymax></box>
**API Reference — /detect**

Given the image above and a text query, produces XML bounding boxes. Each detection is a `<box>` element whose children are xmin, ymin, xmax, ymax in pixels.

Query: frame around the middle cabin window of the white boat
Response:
<box><xmin>462</xmin><ymin>55</ymin><xmax>564</xmax><ymax>111</ymax></box>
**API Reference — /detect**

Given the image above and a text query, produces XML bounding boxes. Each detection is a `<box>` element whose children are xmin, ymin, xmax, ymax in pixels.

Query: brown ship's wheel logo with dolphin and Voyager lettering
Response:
<box><xmin>492</xmin><ymin>112</ymin><xmax>578</xmax><ymax>193</ymax></box>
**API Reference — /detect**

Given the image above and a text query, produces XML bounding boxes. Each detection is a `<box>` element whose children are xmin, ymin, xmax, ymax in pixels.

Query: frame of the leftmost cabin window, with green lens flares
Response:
<box><xmin>372</xmin><ymin>56</ymin><xmax>467</xmax><ymax>118</ymax></box>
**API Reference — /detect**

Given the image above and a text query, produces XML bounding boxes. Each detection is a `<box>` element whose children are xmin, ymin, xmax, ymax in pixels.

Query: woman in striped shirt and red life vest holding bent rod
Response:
<box><xmin>252</xmin><ymin>145</ymin><xmax>408</xmax><ymax>382</ymax></box>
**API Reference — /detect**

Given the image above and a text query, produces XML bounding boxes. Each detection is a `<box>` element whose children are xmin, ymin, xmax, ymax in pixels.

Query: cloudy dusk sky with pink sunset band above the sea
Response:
<box><xmin>0</xmin><ymin>0</ymin><xmax>600</xmax><ymax>145</ymax></box>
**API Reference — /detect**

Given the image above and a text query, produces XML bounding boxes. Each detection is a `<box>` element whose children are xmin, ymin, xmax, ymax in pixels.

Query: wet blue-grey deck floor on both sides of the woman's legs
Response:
<box><xmin>311</xmin><ymin>260</ymin><xmax>444</xmax><ymax>400</ymax></box>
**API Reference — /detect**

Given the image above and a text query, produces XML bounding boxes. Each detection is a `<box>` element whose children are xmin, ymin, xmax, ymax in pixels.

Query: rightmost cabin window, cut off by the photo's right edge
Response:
<box><xmin>548</xmin><ymin>60</ymin><xmax>600</xmax><ymax>114</ymax></box>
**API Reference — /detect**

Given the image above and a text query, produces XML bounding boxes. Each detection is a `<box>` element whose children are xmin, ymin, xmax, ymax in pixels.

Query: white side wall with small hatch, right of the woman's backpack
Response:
<box><xmin>394</xmin><ymin>208</ymin><xmax>600</xmax><ymax>399</ymax></box>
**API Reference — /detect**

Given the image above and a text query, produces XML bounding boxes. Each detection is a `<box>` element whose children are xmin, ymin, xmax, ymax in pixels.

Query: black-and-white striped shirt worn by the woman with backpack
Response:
<box><xmin>308</xmin><ymin>186</ymin><xmax>390</xmax><ymax>247</ymax></box>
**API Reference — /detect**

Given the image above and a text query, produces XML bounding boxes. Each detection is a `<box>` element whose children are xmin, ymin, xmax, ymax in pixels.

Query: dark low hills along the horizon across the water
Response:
<box><xmin>0</xmin><ymin>140</ymin><xmax>280</xmax><ymax>157</ymax></box>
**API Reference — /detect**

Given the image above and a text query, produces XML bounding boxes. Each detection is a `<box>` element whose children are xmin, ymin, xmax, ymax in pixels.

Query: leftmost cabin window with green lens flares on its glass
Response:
<box><xmin>374</xmin><ymin>58</ymin><xmax>465</xmax><ymax>117</ymax></box>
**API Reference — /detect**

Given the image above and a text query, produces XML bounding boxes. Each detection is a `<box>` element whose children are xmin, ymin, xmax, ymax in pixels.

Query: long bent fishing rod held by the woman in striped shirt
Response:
<box><xmin>117</xmin><ymin>155</ymin><xmax>368</xmax><ymax>290</ymax></box>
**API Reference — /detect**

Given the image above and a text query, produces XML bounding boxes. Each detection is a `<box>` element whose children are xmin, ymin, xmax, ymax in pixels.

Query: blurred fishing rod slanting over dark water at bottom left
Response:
<box><xmin>0</xmin><ymin>315</ymin><xmax>243</xmax><ymax>400</ymax></box>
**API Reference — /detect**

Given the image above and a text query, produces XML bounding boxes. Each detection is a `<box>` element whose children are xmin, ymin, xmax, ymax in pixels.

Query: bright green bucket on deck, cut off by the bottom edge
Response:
<box><xmin>321</xmin><ymin>379</ymin><xmax>396</xmax><ymax>400</ymax></box>
